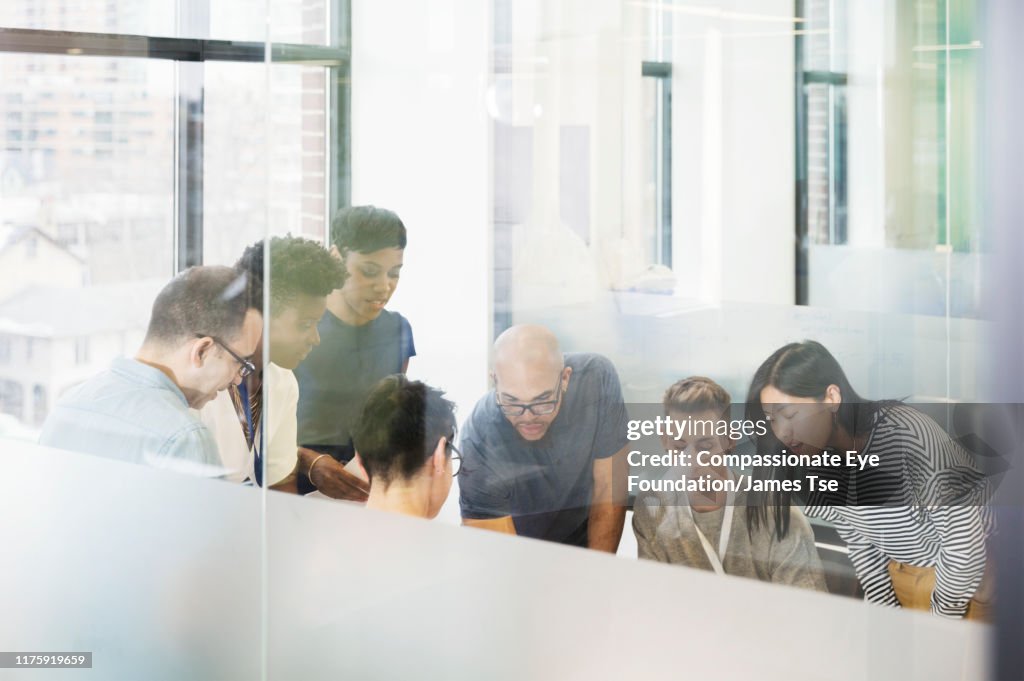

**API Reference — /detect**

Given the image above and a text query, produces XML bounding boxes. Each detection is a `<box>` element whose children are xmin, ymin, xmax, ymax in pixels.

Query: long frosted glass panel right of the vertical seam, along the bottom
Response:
<box><xmin>267</xmin><ymin>477</ymin><xmax>986</xmax><ymax>680</ymax></box>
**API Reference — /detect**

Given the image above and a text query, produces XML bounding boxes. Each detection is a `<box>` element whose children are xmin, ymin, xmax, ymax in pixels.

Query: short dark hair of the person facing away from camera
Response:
<box><xmin>352</xmin><ymin>374</ymin><xmax>456</xmax><ymax>486</ymax></box>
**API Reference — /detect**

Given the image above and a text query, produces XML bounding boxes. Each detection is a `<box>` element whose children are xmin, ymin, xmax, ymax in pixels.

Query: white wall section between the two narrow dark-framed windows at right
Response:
<box><xmin>672</xmin><ymin>0</ymin><xmax>796</xmax><ymax>303</ymax></box>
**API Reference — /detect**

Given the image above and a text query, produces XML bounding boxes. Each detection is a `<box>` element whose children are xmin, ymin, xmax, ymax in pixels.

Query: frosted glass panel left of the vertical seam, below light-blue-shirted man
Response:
<box><xmin>0</xmin><ymin>439</ymin><xmax>262</xmax><ymax>681</ymax></box>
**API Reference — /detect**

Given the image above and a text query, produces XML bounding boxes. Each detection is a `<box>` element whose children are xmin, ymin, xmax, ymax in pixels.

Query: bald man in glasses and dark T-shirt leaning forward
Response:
<box><xmin>459</xmin><ymin>326</ymin><xmax>628</xmax><ymax>553</ymax></box>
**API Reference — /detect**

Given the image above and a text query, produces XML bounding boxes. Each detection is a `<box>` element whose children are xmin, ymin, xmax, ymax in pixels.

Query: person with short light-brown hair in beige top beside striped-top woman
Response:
<box><xmin>633</xmin><ymin>376</ymin><xmax>826</xmax><ymax>591</ymax></box>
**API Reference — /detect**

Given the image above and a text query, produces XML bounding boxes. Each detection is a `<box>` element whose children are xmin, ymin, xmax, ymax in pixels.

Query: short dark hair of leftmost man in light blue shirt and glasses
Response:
<box><xmin>145</xmin><ymin>265</ymin><xmax>259</xmax><ymax>345</ymax></box>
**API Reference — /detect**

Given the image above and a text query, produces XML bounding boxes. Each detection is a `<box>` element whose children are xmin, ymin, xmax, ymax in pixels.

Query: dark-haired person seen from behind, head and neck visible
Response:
<box><xmin>353</xmin><ymin>374</ymin><xmax>460</xmax><ymax>518</ymax></box>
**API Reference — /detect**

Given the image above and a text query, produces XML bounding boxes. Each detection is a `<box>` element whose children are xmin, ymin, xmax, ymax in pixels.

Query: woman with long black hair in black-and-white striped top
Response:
<box><xmin>746</xmin><ymin>340</ymin><xmax>992</xmax><ymax>619</ymax></box>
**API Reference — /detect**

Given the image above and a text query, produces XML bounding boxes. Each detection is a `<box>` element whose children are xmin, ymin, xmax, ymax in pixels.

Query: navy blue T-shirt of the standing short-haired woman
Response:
<box><xmin>295</xmin><ymin>310</ymin><xmax>416</xmax><ymax>460</ymax></box>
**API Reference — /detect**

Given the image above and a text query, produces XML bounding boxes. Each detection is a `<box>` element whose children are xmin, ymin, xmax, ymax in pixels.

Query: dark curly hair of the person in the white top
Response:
<box><xmin>234</xmin><ymin>235</ymin><xmax>347</xmax><ymax>316</ymax></box>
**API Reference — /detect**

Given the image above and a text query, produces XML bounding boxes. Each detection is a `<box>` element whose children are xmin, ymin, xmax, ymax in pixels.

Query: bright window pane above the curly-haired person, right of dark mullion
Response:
<box><xmin>203</xmin><ymin>62</ymin><xmax>328</xmax><ymax>264</ymax></box>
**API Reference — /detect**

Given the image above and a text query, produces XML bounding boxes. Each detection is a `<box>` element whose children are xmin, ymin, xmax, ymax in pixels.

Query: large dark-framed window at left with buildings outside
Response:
<box><xmin>0</xmin><ymin>0</ymin><xmax>349</xmax><ymax>436</ymax></box>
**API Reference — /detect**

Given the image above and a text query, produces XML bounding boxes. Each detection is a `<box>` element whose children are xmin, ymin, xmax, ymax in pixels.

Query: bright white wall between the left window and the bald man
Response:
<box><xmin>352</xmin><ymin>0</ymin><xmax>492</xmax><ymax>520</ymax></box>
